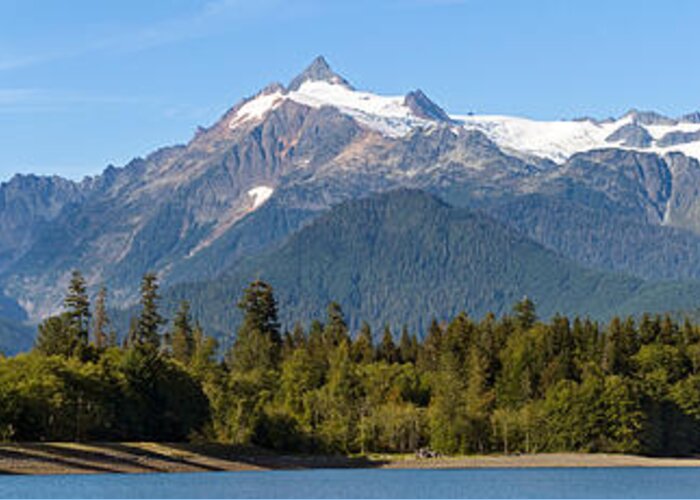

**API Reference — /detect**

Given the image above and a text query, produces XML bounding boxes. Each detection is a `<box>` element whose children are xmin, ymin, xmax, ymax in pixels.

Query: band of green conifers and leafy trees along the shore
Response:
<box><xmin>0</xmin><ymin>273</ymin><xmax>700</xmax><ymax>455</ymax></box>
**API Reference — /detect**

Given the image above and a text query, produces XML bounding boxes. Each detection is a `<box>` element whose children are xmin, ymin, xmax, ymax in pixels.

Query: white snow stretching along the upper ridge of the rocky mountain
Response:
<box><xmin>229</xmin><ymin>80</ymin><xmax>700</xmax><ymax>162</ymax></box>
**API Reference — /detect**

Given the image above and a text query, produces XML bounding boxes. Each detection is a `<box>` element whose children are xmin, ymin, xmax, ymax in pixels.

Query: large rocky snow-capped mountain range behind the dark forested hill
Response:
<box><xmin>0</xmin><ymin>58</ymin><xmax>700</xmax><ymax>350</ymax></box>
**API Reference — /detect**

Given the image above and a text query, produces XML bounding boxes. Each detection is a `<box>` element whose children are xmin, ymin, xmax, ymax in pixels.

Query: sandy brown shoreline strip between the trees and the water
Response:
<box><xmin>0</xmin><ymin>442</ymin><xmax>700</xmax><ymax>475</ymax></box>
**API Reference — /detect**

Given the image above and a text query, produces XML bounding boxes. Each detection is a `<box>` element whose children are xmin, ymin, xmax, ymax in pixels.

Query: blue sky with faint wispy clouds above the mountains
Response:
<box><xmin>0</xmin><ymin>0</ymin><xmax>700</xmax><ymax>180</ymax></box>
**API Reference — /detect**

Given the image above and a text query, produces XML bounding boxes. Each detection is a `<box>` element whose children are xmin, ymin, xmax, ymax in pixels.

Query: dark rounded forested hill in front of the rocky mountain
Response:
<box><xmin>165</xmin><ymin>190</ymin><xmax>700</xmax><ymax>334</ymax></box>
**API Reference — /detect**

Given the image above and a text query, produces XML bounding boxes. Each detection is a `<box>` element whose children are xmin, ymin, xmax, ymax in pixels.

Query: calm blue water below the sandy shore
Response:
<box><xmin>0</xmin><ymin>467</ymin><xmax>700</xmax><ymax>498</ymax></box>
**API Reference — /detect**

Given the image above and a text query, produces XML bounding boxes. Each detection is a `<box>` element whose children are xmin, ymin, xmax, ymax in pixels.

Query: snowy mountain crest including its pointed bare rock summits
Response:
<box><xmin>228</xmin><ymin>57</ymin><xmax>700</xmax><ymax>163</ymax></box>
